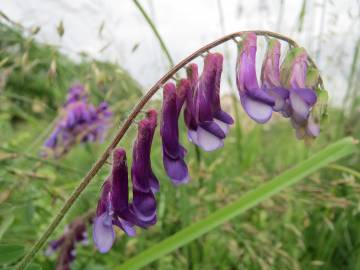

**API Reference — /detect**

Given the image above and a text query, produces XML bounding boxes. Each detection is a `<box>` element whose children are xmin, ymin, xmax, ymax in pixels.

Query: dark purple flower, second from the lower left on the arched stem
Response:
<box><xmin>131</xmin><ymin>111</ymin><xmax>158</xmax><ymax>224</ymax></box>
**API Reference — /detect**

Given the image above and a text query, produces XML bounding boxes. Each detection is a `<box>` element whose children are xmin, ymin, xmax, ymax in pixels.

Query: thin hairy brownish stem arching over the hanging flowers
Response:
<box><xmin>16</xmin><ymin>30</ymin><xmax>322</xmax><ymax>270</ymax></box>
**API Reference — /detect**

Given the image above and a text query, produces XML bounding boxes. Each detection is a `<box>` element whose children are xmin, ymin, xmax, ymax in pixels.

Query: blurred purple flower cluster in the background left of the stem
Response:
<box><xmin>42</xmin><ymin>85</ymin><xmax>112</xmax><ymax>157</ymax></box>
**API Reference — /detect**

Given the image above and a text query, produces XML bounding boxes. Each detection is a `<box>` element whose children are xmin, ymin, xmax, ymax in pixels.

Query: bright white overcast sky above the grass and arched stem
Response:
<box><xmin>0</xmin><ymin>0</ymin><xmax>360</xmax><ymax>104</ymax></box>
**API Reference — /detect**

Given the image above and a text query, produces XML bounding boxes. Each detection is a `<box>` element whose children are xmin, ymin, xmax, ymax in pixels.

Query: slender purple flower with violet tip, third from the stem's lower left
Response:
<box><xmin>160</xmin><ymin>80</ymin><xmax>190</xmax><ymax>185</ymax></box>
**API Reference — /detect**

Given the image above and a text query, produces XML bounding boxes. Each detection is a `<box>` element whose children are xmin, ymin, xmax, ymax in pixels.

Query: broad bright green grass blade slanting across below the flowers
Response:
<box><xmin>117</xmin><ymin>137</ymin><xmax>356</xmax><ymax>270</ymax></box>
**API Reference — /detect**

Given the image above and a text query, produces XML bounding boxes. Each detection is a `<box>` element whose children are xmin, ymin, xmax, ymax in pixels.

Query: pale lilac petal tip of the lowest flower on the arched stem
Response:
<box><xmin>93</xmin><ymin>212</ymin><xmax>115</xmax><ymax>253</ymax></box>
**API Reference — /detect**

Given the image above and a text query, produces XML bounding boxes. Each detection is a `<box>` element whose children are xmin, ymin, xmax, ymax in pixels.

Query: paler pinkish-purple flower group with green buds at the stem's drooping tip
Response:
<box><xmin>236</xmin><ymin>33</ymin><xmax>320</xmax><ymax>140</ymax></box>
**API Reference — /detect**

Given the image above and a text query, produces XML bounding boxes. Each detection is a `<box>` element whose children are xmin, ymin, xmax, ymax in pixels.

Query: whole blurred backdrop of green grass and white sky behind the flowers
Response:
<box><xmin>0</xmin><ymin>0</ymin><xmax>360</xmax><ymax>270</ymax></box>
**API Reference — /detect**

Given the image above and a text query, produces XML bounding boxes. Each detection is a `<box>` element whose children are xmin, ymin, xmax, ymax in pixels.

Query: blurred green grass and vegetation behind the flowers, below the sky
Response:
<box><xmin>0</xmin><ymin>10</ymin><xmax>360</xmax><ymax>270</ymax></box>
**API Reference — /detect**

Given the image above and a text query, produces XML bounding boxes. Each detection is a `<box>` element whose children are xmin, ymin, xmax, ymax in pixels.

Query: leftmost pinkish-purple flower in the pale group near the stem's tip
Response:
<box><xmin>236</xmin><ymin>33</ymin><xmax>275</xmax><ymax>123</ymax></box>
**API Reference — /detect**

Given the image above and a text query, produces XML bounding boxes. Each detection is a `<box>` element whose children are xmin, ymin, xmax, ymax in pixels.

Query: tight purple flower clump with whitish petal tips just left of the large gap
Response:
<box><xmin>184</xmin><ymin>53</ymin><xmax>233</xmax><ymax>151</ymax></box>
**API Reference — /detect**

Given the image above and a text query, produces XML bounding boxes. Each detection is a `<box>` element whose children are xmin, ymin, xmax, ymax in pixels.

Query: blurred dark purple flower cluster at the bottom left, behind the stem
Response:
<box><xmin>45</xmin><ymin>218</ymin><xmax>89</xmax><ymax>270</ymax></box>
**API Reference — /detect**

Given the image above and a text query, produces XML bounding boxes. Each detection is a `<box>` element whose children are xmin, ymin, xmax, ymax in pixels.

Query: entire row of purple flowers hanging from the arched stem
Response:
<box><xmin>93</xmin><ymin>33</ymin><xmax>326</xmax><ymax>252</ymax></box>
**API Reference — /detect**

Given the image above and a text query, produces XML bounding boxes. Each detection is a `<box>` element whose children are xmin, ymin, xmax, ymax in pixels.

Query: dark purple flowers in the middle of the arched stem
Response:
<box><xmin>160</xmin><ymin>53</ymin><xmax>234</xmax><ymax>185</ymax></box>
